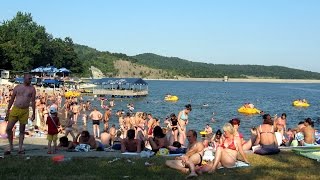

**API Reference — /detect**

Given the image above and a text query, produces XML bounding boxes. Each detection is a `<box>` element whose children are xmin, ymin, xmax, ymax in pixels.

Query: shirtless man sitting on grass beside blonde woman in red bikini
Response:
<box><xmin>166</xmin><ymin>130</ymin><xmax>204</xmax><ymax>177</ymax></box>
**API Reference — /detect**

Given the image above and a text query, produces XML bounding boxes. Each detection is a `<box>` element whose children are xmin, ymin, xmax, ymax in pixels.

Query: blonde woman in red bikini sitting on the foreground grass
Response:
<box><xmin>197</xmin><ymin>123</ymin><xmax>249</xmax><ymax>174</ymax></box>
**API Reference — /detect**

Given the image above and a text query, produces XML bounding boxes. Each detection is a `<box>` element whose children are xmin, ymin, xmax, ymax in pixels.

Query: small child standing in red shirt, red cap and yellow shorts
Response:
<box><xmin>46</xmin><ymin>107</ymin><xmax>61</xmax><ymax>154</ymax></box>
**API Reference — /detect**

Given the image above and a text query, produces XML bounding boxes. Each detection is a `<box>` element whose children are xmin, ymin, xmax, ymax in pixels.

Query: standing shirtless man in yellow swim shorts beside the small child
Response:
<box><xmin>5</xmin><ymin>74</ymin><xmax>36</xmax><ymax>155</ymax></box>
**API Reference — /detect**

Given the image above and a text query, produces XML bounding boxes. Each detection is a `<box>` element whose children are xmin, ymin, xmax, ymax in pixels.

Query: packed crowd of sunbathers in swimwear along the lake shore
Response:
<box><xmin>1</xmin><ymin>83</ymin><xmax>319</xmax><ymax>179</ymax></box>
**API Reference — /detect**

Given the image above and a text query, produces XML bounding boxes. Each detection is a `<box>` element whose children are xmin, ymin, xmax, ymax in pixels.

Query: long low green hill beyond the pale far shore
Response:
<box><xmin>133</xmin><ymin>53</ymin><xmax>320</xmax><ymax>79</ymax></box>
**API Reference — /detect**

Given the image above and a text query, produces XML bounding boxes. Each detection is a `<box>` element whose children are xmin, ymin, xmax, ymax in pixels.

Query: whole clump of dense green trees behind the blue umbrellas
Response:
<box><xmin>0</xmin><ymin>12</ymin><xmax>83</xmax><ymax>73</ymax></box>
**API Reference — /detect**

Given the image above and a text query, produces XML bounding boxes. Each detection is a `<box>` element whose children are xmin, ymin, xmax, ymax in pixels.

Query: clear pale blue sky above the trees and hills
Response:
<box><xmin>0</xmin><ymin>0</ymin><xmax>320</xmax><ymax>72</ymax></box>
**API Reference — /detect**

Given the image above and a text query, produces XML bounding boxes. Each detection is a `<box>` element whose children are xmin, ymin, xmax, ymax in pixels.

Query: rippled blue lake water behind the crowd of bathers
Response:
<box><xmin>81</xmin><ymin>81</ymin><xmax>320</xmax><ymax>139</ymax></box>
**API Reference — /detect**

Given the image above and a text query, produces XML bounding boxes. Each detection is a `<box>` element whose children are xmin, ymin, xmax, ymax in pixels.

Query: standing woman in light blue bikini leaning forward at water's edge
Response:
<box><xmin>178</xmin><ymin>104</ymin><xmax>192</xmax><ymax>146</ymax></box>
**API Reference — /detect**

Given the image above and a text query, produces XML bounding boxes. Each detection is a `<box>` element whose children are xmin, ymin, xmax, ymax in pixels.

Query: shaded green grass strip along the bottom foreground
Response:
<box><xmin>0</xmin><ymin>152</ymin><xmax>320</xmax><ymax>180</ymax></box>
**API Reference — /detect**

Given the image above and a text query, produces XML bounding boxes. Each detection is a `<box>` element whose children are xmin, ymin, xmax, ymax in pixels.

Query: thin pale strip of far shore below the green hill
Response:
<box><xmin>144</xmin><ymin>78</ymin><xmax>320</xmax><ymax>83</ymax></box>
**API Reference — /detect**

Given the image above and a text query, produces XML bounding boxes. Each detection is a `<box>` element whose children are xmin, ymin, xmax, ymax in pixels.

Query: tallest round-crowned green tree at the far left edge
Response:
<box><xmin>0</xmin><ymin>12</ymin><xmax>48</xmax><ymax>70</ymax></box>
